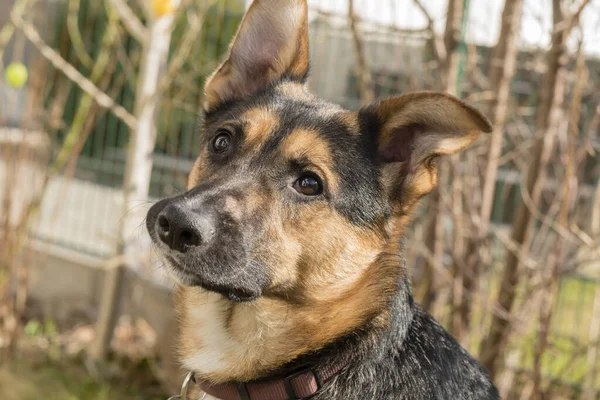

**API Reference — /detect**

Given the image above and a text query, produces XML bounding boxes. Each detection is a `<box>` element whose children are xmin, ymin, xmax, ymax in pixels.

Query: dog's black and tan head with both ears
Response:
<box><xmin>147</xmin><ymin>0</ymin><xmax>490</xmax><ymax>307</ymax></box>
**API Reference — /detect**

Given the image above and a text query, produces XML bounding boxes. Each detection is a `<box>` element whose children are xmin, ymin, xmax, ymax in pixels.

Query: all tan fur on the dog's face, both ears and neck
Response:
<box><xmin>175</xmin><ymin>0</ymin><xmax>490</xmax><ymax>390</ymax></box>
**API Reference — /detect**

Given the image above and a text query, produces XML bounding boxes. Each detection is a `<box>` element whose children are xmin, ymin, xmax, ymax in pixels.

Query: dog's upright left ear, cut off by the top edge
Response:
<box><xmin>204</xmin><ymin>0</ymin><xmax>308</xmax><ymax>111</ymax></box>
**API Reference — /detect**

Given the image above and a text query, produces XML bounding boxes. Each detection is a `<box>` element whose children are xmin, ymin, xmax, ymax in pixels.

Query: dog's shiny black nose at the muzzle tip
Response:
<box><xmin>156</xmin><ymin>204</ymin><xmax>207</xmax><ymax>253</ymax></box>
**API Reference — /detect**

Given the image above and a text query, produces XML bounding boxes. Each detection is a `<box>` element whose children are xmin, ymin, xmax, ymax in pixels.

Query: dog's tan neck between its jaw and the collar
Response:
<box><xmin>172</xmin><ymin>260</ymin><xmax>413</xmax><ymax>383</ymax></box>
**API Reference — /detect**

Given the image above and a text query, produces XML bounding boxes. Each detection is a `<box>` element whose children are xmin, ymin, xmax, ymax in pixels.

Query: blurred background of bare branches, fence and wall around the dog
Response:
<box><xmin>0</xmin><ymin>0</ymin><xmax>600</xmax><ymax>400</ymax></box>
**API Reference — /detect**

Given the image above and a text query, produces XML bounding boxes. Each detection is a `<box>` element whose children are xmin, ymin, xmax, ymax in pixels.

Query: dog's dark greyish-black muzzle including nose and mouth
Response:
<box><xmin>146</xmin><ymin>189</ymin><xmax>269</xmax><ymax>302</ymax></box>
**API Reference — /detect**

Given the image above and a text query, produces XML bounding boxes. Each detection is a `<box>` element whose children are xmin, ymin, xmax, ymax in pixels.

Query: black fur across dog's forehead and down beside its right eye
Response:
<box><xmin>202</xmin><ymin>78</ymin><xmax>387</xmax><ymax>226</ymax></box>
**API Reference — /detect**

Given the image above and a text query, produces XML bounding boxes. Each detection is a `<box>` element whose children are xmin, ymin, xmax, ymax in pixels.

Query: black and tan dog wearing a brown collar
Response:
<box><xmin>146</xmin><ymin>0</ymin><xmax>499</xmax><ymax>400</ymax></box>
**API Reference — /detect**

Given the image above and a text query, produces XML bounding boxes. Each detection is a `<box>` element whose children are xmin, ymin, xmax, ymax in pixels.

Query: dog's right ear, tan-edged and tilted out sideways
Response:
<box><xmin>360</xmin><ymin>92</ymin><xmax>492</xmax><ymax>211</ymax></box>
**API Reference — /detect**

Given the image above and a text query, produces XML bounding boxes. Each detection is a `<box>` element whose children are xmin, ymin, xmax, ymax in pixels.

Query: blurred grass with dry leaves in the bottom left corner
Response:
<box><xmin>0</xmin><ymin>312</ymin><xmax>168</xmax><ymax>400</ymax></box>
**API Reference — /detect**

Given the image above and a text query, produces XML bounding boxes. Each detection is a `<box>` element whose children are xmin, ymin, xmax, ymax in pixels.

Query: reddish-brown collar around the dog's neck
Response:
<box><xmin>196</xmin><ymin>362</ymin><xmax>348</xmax><ymax>400</ymax></box>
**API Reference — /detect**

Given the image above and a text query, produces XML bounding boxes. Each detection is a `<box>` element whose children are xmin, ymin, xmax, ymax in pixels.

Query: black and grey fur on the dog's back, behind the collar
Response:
<box><xmin>274</xmin><ymin>278</ymin><xmax>500</xmax><ymax>400</ymax></box>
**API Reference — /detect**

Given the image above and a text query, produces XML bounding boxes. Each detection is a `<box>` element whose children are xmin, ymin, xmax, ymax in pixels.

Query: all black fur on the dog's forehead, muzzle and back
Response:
<box><xmin>147</xmin><ymin>79</ymin><xmax>499</xmax><ymax>400</ymax></box>
